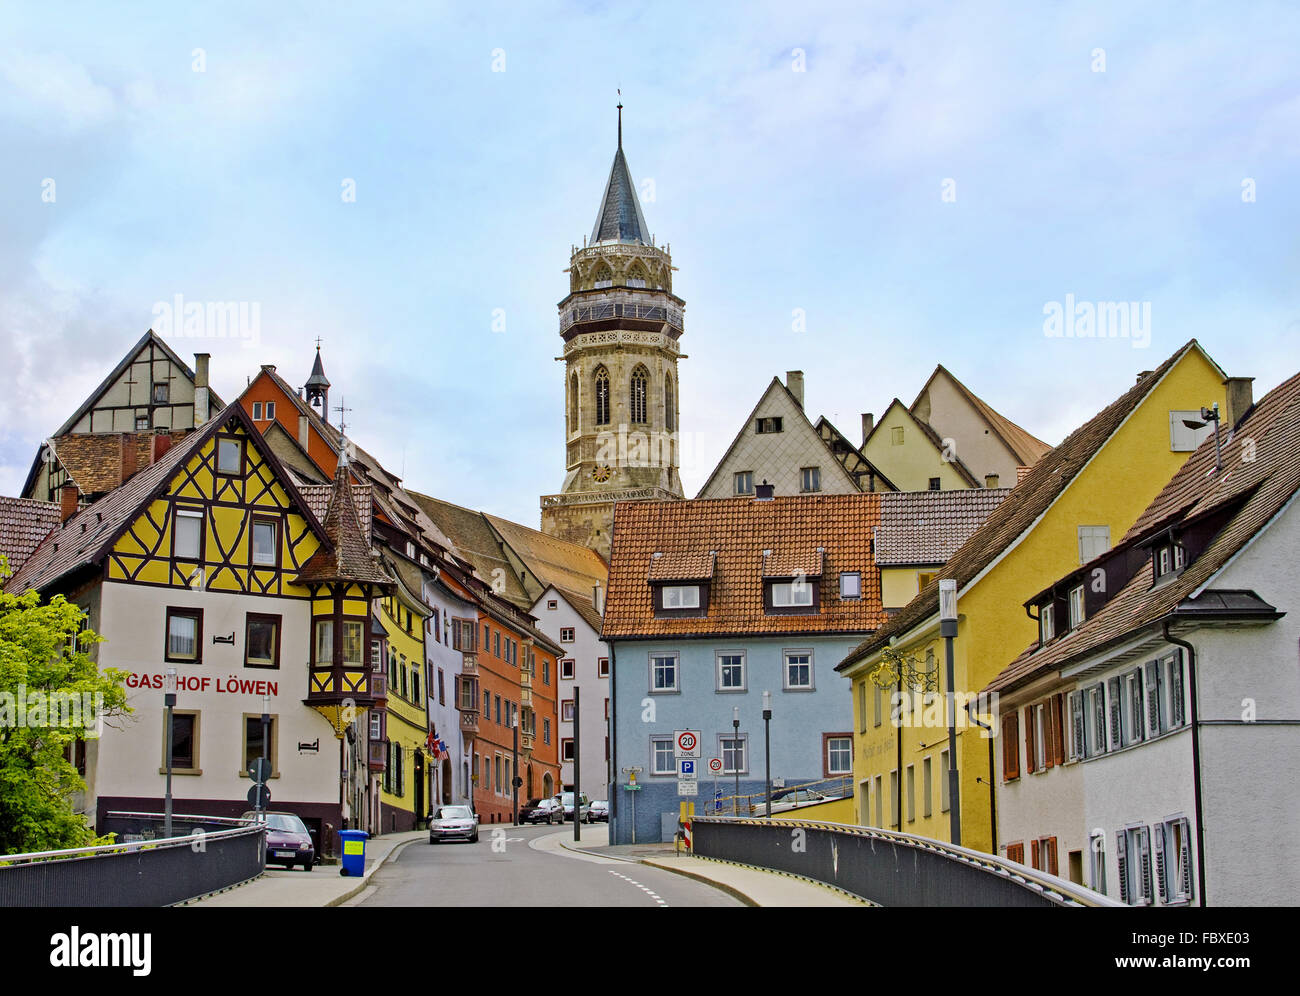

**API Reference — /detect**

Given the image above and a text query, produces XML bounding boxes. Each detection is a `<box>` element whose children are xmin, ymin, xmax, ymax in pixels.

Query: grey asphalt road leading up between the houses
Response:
<box><xmin>346</xmin><ymin>826</ymin><xmax>744</xmax><ymax>908</ymax></box>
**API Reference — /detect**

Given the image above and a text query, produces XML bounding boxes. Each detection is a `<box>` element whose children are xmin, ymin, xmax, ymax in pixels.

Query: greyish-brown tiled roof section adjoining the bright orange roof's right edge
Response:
<box><xmin>876</xmin><ymin>488</ymin><xmax>1011</xmax><ymax>567</ymax></box>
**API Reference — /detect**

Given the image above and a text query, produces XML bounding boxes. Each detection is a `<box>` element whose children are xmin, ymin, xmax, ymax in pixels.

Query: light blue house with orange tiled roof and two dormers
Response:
<box><xmin>603</xmin><ymin>493</ymin><xmax>885</xmax><ymax>844</ymax></box>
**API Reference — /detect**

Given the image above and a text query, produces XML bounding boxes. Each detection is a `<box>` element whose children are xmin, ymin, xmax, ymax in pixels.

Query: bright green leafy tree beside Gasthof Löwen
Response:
<box><xmin>0</xmin><ymin>555</ymin><xmax>130</xmax><ymax>854</ymax></box>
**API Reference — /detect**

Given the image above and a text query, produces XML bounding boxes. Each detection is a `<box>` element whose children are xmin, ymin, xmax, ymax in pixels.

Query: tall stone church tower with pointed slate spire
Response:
<box><xmin>542</xmin><ymin>104</ymin><xmax>685</xmax><ymax>558</ymax></box>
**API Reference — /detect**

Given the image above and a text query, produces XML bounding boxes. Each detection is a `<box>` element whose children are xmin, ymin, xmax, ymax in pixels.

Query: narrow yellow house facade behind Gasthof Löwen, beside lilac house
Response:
<box><xmin>380</xmin><ymin>570</ymin><xmax>433</xmax><ymax>833</ymax></box>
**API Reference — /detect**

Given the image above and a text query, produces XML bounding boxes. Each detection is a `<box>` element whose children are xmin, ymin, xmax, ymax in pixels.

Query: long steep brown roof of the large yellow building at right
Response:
<box><xmin>836</xmin><ymin>339</ymin><xmax>1204</xmax><ymax>671</ymax></box>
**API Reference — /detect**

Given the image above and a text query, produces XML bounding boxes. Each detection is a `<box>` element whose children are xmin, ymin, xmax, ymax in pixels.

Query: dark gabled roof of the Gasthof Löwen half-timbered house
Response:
<box><xmin>5</xmin><ymin>402</ymin><xmax>325</xmax><ymax>593</ymax></box>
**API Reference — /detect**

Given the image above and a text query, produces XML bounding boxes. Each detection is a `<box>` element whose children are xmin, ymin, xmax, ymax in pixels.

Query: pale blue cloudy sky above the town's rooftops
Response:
<box><xmin>0</xmin><ymin>0</ymin><xmax>1300</xmax><ymax>525</ymax></box>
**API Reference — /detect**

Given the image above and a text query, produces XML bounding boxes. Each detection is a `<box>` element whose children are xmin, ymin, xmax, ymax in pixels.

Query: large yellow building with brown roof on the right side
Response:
<box><xmin>836</xmin><ymin>339</ymin><xmax>1226</xmax><ymax>850</ymax></box>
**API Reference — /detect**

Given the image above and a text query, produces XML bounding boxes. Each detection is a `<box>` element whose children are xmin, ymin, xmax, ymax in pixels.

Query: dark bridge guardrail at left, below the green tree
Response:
<box><xmin>0</xmin><ymin>814</ymin><xmax>267</xmax><ymax>906</ymax></box>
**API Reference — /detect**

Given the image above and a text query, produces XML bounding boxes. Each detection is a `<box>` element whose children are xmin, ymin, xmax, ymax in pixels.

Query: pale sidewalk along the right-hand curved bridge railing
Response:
<box><xmin>560</xmin><ymin>826</ymin><xmax>871</xmax><ymax>906</ymax></box>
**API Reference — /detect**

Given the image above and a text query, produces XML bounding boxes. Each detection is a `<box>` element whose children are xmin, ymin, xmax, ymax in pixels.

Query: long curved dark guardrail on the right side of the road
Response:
<box><xmin>692</xmin><ymin>817</ymin><xmax>1123</xmax><ymax>908</ymax></box>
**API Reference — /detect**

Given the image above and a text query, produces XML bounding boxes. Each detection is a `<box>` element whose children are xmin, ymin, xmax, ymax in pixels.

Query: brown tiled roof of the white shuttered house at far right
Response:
<box><xmin>988</xmin><ymin>374</ymin><xmax>1300</xmax><ymax>692</ymax></box>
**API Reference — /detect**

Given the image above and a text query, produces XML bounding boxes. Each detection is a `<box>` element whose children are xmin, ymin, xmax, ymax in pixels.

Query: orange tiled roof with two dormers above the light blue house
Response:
<box><xmin>603</xmin><ymin>491</ymin><xmax>885</xmax><ymax>640</ymax></box>
